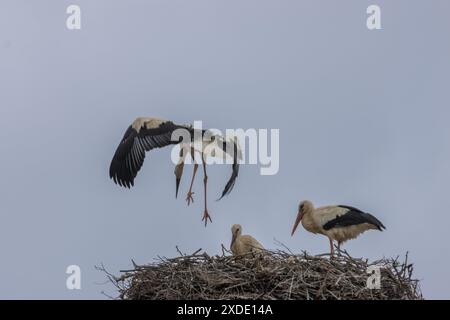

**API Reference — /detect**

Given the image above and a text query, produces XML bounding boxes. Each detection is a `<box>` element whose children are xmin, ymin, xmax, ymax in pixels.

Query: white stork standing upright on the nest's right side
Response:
<box><xmin>291</xmin><ymin>200</ymin><xmax>385</xmax><ymax>256</ymax></box>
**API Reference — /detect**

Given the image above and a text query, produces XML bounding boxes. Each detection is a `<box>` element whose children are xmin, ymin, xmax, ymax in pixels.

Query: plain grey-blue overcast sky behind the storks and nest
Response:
<box><xmin>0</xmin><ymin>0</ymin><xmax>450</xmax><ymax>299</ymax></box>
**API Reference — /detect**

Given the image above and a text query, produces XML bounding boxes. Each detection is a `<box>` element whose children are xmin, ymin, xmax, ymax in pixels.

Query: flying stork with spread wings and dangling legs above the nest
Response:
<box><xmin>109</xmin><ymin>117</ymin><xmax>242</xmax><ymax>226</ymax></box>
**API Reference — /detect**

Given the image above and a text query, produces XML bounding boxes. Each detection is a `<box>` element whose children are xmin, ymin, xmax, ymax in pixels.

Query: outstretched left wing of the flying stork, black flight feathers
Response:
<box><xmin>109</xmin><ymin>119</ymin><xmax>185</xmax><ymax>188</ymax></box>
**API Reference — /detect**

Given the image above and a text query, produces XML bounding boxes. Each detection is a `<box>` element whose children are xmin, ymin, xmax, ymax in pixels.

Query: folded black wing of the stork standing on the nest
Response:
<box><xmin>323</xmin><ymin>206</ymin><xmax>385</xmax><ymax>231</ymax></box>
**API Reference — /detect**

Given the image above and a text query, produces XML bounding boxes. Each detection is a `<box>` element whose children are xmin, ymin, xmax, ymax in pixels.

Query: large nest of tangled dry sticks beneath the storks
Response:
<box><xmin>100</xmin><ymin>250</ymin><xmax>422</xmax><ymax>300</ymax></box>
